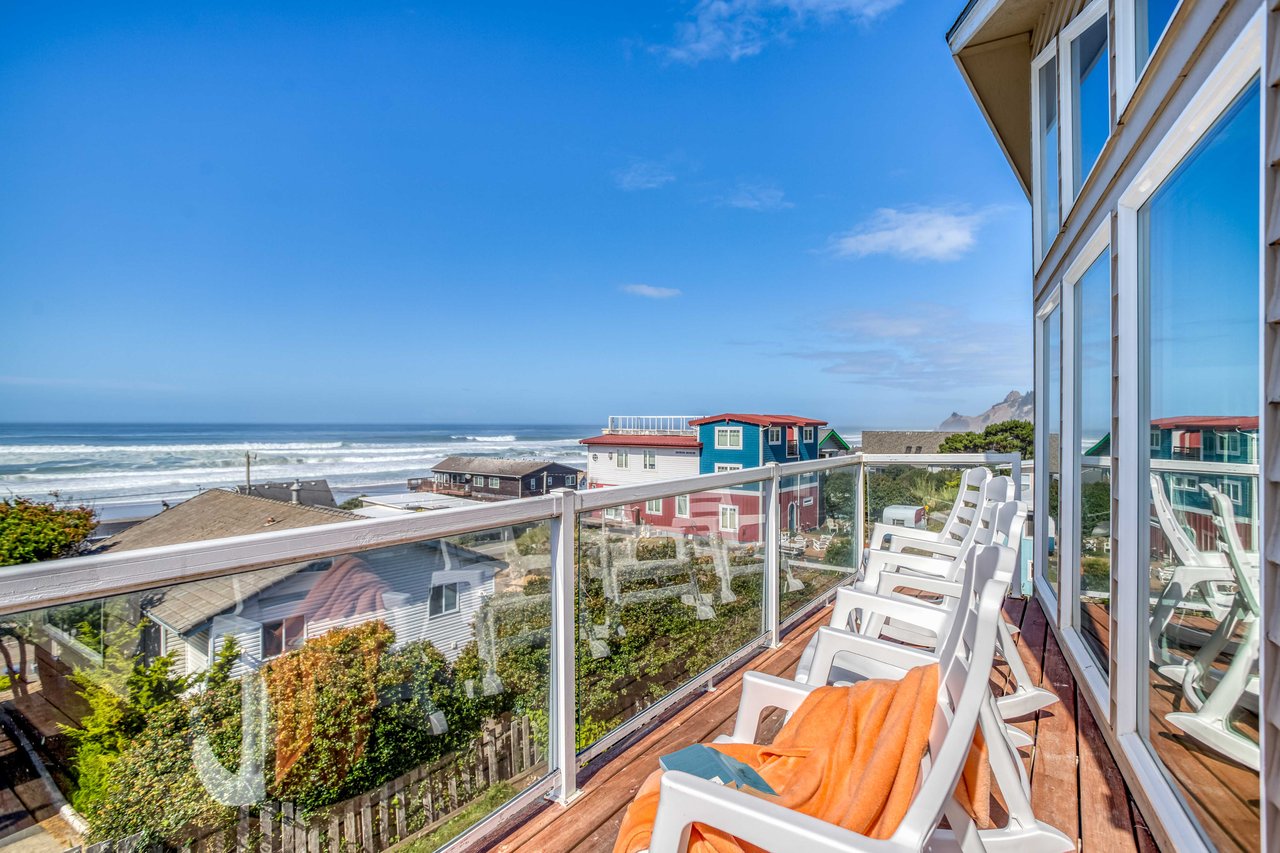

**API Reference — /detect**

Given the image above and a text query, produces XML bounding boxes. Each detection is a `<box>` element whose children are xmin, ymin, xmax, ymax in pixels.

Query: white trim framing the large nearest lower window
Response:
<box><xmin>1111</xmin><ymin>6</ymin><xmax>1266</xmax><ymax>849</ymax></box>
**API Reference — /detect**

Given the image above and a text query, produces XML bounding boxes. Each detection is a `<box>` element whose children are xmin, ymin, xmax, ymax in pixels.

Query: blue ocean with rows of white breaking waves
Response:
<box><xmin>0</xmin><ymin>424</ymin><xmax>600</xmax><ymax>520</ymax></box>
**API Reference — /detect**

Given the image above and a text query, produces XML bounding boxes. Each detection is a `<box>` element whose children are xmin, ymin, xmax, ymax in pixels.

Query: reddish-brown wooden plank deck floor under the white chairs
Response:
<box><xmin>484</xmin><ymin>599</ymin><xmax>1157</xmax><ymax>853</ymax></box>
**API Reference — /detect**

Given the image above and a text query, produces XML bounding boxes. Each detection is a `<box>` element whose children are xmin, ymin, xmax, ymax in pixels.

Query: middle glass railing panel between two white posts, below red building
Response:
<box><xmin>576</xmin><ymin>483</ymin><xmax>767</xmax><ymax>749</ymax></box>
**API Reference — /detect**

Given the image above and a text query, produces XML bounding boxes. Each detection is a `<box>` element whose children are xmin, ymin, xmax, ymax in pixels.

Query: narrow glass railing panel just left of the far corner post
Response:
<box><xmin>778</xmin><ymin>465</ymin><xmax>861</xmax><ymax>622</ymax></box>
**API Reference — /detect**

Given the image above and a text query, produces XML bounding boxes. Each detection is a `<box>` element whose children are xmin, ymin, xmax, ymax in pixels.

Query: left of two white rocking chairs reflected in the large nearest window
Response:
<box><xmin>1149</xmin><ymin>473</ymin><xmax>1235</xmax><ymax>663</ymax></box>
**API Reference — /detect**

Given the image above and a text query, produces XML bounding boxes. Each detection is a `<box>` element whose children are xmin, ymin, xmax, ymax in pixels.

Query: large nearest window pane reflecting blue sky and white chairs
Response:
<box><xmin>1138</xmin><ymin>82</ymin><xmax>1261</xmax><ymax>849</ymax></box>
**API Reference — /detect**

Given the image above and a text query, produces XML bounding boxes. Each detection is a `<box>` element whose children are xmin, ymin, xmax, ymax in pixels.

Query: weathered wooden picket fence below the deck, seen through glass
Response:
<box><xmin>69</xmin><ymin>717</ymin><xmax>545</xmax><ymax>853</ymax></box>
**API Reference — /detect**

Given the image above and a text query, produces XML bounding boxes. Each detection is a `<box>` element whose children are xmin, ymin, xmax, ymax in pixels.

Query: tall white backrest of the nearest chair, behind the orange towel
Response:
<box><xmin>893</xmin><ymin>546</ymin><xmax>1016</xmax><ymax>849</ymax></box>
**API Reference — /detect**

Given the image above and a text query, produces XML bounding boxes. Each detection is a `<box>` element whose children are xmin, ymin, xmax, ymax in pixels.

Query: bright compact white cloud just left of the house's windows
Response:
<box><xmin>831</xmin><ymin>207</ymin><xmax>983</xmax><ymax>261</ymax></box>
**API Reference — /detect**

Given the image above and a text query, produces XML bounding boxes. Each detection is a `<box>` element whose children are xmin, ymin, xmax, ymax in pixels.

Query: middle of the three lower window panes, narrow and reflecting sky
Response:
<box><xmin>1075</xmin><ymin>248</ymin><xmax>1111</xmax><ymax>671</ymax></box>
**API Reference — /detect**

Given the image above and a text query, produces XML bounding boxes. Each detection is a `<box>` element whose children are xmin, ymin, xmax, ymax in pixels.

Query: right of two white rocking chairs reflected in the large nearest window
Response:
<box><xmin>1160</xmin><ymin>485</ymin><xmax>1262</xmax><ymax>770</ymax></box>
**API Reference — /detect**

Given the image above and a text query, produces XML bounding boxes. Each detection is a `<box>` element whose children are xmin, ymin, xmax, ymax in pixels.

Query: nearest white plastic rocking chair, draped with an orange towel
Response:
<box><xmin>649</xmin><ymin>548</ymin><xmax>1075</xmax><ymax>853</ymax></box>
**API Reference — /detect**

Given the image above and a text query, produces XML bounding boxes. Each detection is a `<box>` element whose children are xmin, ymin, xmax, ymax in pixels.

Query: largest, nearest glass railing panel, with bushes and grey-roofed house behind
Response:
<box><xmin>0</xmin><ymin>521</ymin><xmax>550</xmax><ymax>850</ymax></box>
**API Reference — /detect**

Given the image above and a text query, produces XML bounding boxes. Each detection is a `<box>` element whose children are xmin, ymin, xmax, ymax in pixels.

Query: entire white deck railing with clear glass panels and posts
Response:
<box><xmin>0</xmin><ymin>453</ymin><xmax>1020</xmax><ymax>849</ymax></box>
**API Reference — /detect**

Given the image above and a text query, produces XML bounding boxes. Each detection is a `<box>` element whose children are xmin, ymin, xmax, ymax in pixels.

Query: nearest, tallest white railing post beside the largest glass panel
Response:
<box><xmin>550</xmin><ymin>489</ymin><xmax>577</xmax><ymax>806</ymax></box>
